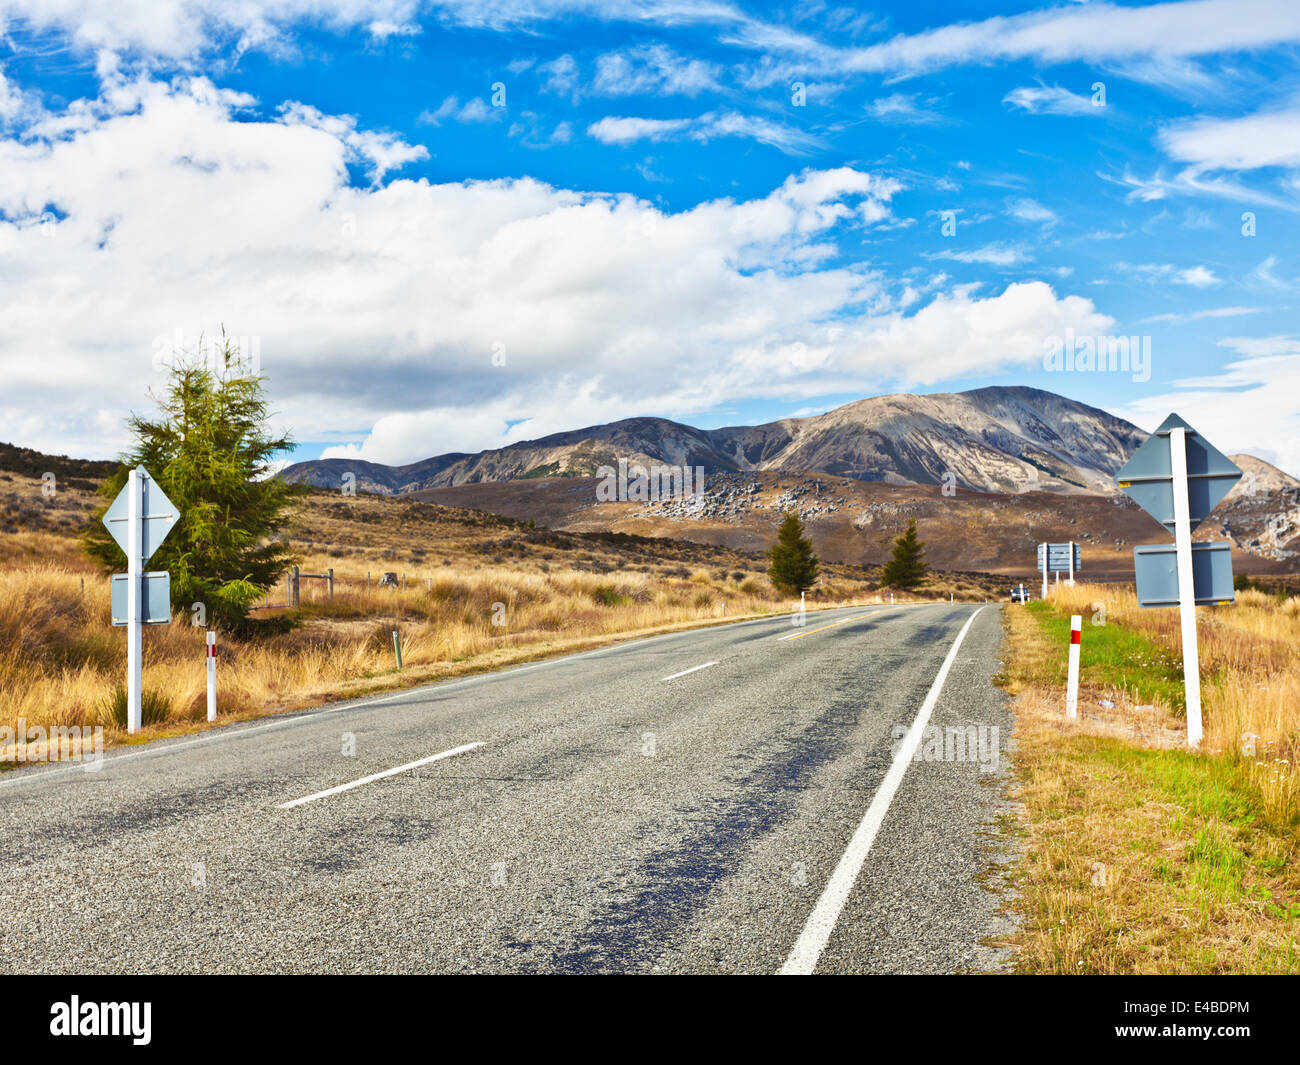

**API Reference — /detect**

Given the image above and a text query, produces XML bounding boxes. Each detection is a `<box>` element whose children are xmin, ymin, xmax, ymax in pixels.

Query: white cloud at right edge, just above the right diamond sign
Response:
<box><xmin>1117</xmin><ymin>335</ymin><xmax>1300</xmax><ymax>476</ymax></box>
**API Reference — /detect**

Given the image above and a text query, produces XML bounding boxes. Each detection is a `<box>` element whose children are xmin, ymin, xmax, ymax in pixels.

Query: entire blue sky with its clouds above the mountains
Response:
<box><xmin>0</xmin><ymin>0</ymin><xmax>1300</xmax><ymax>473</ymax></box>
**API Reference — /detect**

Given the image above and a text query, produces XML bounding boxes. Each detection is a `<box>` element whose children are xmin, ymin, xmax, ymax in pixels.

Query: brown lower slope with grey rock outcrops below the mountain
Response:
<box><xmin>415</xmin><ymin>455</ymin><xmax>1300</xmax><ymax>581</ymax></box>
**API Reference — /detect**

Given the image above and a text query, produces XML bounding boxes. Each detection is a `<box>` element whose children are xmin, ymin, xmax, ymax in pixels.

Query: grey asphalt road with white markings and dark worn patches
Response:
<box><xmin>0</xmin><ymin>603</ymin><xmax>1010</xmax><ymax>973</ymax></box>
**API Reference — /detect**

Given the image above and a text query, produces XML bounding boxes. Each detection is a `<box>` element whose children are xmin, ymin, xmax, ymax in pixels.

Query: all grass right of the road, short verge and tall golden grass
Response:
<box><xmin>1004</xmin><ymin>585</ymin><xmax>1300</xmax><ymax>973</ymax></box>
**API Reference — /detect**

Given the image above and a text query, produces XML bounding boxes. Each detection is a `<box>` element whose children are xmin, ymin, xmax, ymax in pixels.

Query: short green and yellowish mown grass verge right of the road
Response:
<box><xmin>1002</xmin><ymin>603</ymin><xmax>1300</xmax><ymax>974</ymax></box>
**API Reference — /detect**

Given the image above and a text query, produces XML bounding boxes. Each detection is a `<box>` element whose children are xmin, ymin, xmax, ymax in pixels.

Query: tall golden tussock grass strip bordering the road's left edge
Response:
<box><xmin>0</xmin><ymin>557</ymin><xmax>879</xmax><ymax>761</ymax></box>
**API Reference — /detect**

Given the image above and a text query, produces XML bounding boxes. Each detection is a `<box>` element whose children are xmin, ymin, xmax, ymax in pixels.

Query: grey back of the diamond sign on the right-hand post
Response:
<box><xmin>1115</xmin><ymin>415</ymin><xmax>1242</xmax><ymax>531</ymax></box>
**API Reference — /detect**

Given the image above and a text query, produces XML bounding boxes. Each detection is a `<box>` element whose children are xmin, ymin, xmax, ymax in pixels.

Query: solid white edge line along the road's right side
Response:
<box><xmin>777</xmin><ymin>606</ymin><xmax>984</xmax><ymax>977</ymax></box>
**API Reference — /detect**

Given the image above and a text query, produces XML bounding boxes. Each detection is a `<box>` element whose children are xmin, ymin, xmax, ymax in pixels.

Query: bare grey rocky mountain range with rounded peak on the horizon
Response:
<box><xmin>281</xmin><ymin>388</ymin><xmax>1147</xmax><ymax>493</ymax></box>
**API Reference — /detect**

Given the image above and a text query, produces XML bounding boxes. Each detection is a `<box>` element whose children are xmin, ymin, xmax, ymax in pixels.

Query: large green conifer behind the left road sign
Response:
<box><xmin>82</xmin><ymin>341</ymin><xmax>299</xmax><ymax>628</ymax></box>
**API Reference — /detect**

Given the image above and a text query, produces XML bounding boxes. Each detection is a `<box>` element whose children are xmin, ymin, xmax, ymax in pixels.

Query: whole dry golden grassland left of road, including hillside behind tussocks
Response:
<box><xmin>0</xmin><ymin>486</ymin><xmax>894</xmax><ymax>765</ymax></box>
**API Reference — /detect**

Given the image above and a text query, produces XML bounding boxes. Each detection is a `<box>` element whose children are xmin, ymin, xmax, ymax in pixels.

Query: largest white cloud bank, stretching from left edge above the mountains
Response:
<box><xmin>0</xmin><ymin>69</ymin><xmax>1104</xmax><ymax>462</ymax></box>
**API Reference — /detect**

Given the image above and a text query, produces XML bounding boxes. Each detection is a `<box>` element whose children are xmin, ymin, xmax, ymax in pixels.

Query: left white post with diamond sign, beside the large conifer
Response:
<box><xmin>104</xmin><ymin>466</ymin><xmax>181</xmax><ymax>732</ymax></box>
